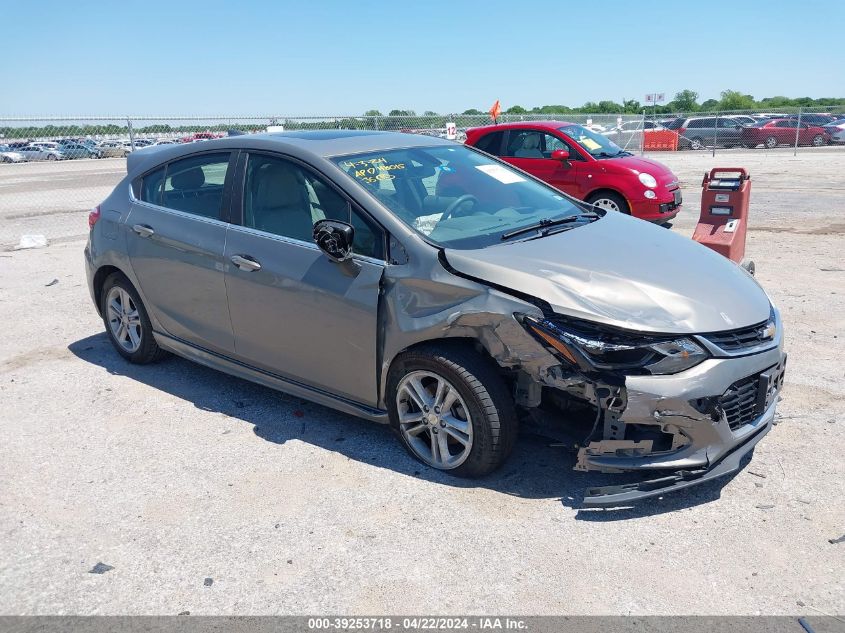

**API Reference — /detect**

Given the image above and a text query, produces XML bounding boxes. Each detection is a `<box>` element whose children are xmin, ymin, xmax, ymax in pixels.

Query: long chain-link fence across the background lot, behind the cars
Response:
<box><xmin>0</xmin><ymin>106</ymin><xmax>845</xmax><ymax>157</ymax></box>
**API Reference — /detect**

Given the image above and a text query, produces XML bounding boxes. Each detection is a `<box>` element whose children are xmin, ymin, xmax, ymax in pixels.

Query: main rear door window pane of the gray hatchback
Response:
<box><xmin>159</xmin><ymin>152</ymin><xmax>229</xmax><ymax>219</ymax></box>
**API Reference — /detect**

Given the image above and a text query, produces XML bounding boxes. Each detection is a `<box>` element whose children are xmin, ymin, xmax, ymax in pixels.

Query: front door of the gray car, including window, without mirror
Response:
<box><xmin>225</xmin><ymin>153</ymin><xmax>385</xmax><ymax>406</ymax></box>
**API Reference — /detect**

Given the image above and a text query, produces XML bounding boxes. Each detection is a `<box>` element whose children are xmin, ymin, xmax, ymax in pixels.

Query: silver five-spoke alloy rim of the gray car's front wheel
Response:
<box><xmin>396</xmin><ymin>371</ymin><xmax>472</xmax><ymax>470</ymax></box>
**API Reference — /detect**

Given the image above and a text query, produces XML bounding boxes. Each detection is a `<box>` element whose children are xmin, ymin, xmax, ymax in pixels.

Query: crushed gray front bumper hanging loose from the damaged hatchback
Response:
<box><xmin>564</xmin><ymin>328</ymin><xmax>786</xmax><ymax>508</ymax></box>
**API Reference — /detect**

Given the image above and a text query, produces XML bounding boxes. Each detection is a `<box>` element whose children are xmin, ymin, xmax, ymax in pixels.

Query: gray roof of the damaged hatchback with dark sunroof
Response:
<box><xmin>126</xmin><ymin>130</ymin><xmax>456</xmax><ymax>175</ymax></box>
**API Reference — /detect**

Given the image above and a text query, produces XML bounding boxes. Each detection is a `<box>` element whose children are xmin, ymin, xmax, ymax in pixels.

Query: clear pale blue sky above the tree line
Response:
<box><xmin>0</xmin><ymin>0</ymin><xmax>845</xmax><ymax>116</ymax></box>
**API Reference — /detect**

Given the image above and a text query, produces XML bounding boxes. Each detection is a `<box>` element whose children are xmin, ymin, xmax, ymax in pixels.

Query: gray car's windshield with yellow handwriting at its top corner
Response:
<box><xmin>333</xmin><ymin>144</ymin><xmax>588</xmax><ymax>249</ymax></box>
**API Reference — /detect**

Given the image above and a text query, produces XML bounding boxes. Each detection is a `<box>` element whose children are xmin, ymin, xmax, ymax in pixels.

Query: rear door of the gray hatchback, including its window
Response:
<box><xmin>126</xmin><ymin>151</ymin><xmax>234</xmax><ymax>354</ymax></box>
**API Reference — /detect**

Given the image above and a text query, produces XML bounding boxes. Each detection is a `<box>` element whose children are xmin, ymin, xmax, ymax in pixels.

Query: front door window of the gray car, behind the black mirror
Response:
<box><xmin>243</xmin><ymin>155</ymin><xmax>384</xmax><ymax>259</ymax></box>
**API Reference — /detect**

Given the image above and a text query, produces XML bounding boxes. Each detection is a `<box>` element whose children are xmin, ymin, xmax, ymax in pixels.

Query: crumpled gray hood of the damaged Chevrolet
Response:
<box><xmin>445</xmin><ymin>213</ymin><xmax>770</xmax><ymax>334</ymax></box>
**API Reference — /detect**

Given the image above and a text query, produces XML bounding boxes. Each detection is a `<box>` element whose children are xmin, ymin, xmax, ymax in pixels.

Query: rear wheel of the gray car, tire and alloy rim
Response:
<box><xmin>100</xmin><ymin>273</ymin><xmax>167</xmax><ymax>365</ymax></box>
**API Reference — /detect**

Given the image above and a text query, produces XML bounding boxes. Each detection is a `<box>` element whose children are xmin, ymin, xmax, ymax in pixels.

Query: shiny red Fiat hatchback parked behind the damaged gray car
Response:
<box><xmin>466</xmin><ymin>121</ymin><xmax>681</xmax><ymax>223</ymax></box>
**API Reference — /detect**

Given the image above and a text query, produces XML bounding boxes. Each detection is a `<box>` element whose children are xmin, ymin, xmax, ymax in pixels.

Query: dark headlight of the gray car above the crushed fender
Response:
<box><xmin>522</xmin><ymin>317</ymin><xmax>709</xmax><ymax>375</ymax></box>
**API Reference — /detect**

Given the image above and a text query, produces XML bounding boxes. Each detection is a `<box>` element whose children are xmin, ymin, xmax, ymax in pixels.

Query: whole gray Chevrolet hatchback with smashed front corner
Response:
<box><xmin>85</xmin><ymin>130</ymin><xmax>786</xmax><ymax>506</ymax></box>
